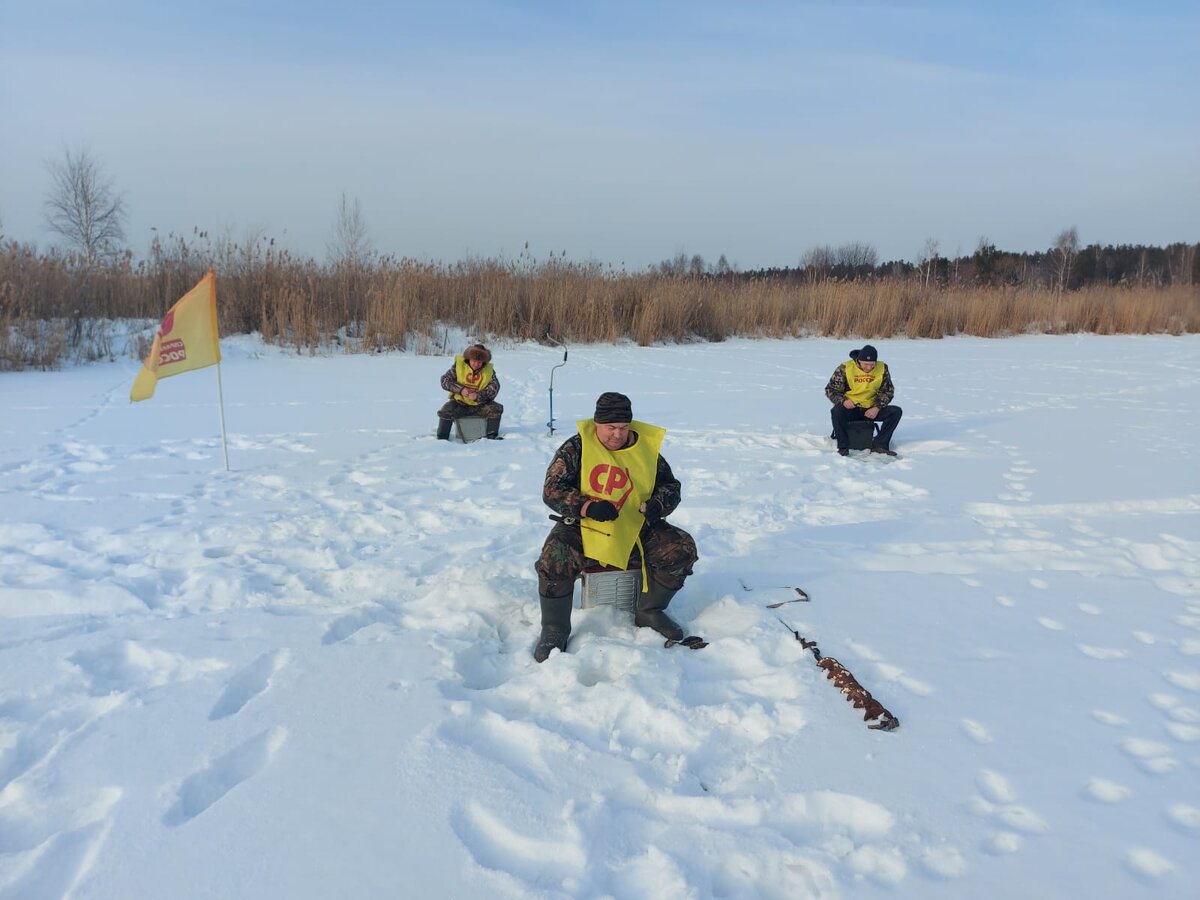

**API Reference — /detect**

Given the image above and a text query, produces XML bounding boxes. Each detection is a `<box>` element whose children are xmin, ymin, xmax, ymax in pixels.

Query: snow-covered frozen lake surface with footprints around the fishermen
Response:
<box><xmin>0</xmin><ymin>336</ymin><xmax>1200</xmax><ymax>900</ymax></box>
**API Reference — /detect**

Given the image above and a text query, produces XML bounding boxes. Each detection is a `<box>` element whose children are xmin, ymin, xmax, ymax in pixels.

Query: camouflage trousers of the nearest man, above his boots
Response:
<box><xmin>534</xmin><ymin>521</ymin><xmax>700</xmax><ymax>596</ymax></box>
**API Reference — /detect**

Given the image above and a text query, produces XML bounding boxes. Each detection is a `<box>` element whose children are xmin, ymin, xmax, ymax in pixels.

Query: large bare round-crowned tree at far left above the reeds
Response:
<box><xmin>44</xmin><ymin>148</ymin><xmax>125</xmax><ymax>265</ymax></box>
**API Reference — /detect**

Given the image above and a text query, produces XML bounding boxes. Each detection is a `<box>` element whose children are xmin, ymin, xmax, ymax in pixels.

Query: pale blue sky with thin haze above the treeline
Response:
<box><xmin>0</xmin><ymin>0</ymin><xmax>1200</xmax><ymax>269</ymax></box>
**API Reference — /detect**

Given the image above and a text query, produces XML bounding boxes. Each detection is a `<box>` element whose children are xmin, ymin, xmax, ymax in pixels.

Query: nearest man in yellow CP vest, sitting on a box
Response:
<box><xmin>533</xmin><ymin>391</ymin><xmax>704</xmax><ymax>662</ymax></box>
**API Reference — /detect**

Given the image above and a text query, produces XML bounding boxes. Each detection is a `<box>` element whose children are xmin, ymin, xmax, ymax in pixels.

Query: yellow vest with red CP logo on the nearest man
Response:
<box><xmin>576</xmin><ymin>419</ymin><xmax>667</xmax><ymax>592</ymax></box>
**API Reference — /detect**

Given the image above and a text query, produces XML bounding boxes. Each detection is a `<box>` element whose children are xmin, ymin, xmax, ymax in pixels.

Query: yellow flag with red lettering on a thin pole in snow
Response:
<box><xmin>130</xmin><ymin>269</ymin><xmax>221</xmax><ymax>402</ymax></box>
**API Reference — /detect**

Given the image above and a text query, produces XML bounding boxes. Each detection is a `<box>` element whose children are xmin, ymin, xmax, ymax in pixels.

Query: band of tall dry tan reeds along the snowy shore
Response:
<box><xmin>0</xmin><ymin>234</ymin><xmax>1200</xmax><ymax>370</ymax></box>
